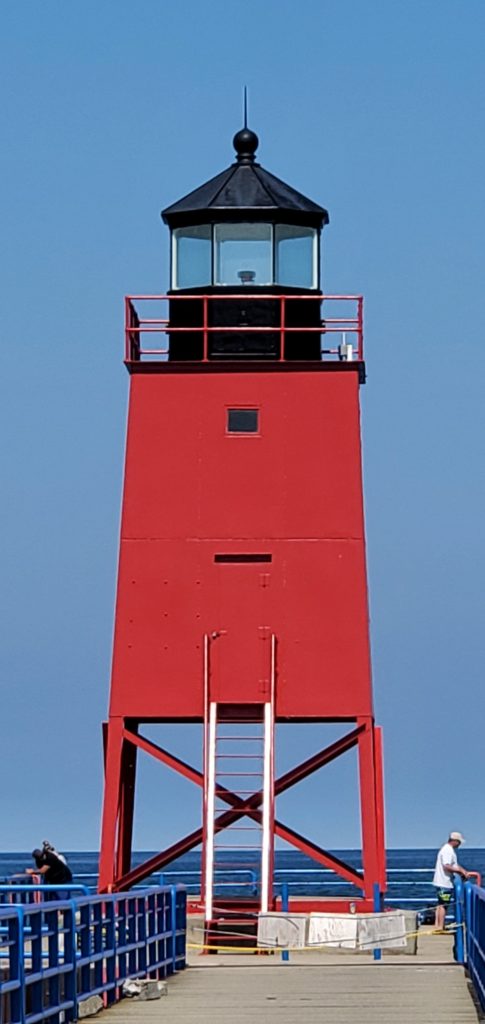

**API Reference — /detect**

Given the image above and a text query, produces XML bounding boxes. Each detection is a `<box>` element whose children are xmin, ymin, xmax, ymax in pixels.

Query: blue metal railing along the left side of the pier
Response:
<box><xmin>0</xmin><ymin>886</ymin><xmax>186</xmax><ymax>1024</ymax></box>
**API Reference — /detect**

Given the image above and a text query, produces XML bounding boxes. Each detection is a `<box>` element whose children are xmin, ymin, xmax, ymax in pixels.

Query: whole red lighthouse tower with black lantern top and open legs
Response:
<box><xmin>100</xmin><ymin>128</ymin><xmax>385</xmax><ymax>921</ymax></box>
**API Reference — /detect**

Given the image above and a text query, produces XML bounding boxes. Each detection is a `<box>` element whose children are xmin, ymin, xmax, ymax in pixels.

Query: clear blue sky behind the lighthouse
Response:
<box><xmin>0</xmin><ymin>0</ymin><xmax>485</xmax><ymax>850</ymax></box>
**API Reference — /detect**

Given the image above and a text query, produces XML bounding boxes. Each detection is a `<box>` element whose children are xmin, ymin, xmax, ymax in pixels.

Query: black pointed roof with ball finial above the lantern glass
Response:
<box><xmin>162</xmin><ymin>128</ymin><xmax>328</xmax><ymax>228</ymax></box>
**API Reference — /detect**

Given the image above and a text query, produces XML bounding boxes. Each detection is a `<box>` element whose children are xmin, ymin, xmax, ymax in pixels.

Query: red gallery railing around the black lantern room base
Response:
<box><xmin>125</xmin><ymin>292</ymin><xmax>363</xmax><ymax>365</ymax></box>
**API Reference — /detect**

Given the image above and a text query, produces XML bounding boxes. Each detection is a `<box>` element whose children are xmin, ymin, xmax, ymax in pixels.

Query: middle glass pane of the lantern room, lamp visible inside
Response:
<box><xmin>214</xmin><ymin>224</ymin><xmax>273</xmax><ymax>289</ymax></box>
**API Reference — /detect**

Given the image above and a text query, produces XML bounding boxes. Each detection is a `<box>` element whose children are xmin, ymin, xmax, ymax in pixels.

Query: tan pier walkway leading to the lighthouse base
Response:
<box><xmin>102</xmin><ymin>935</ymin><xmax>479</xmax><ymax>1024</ymax></box>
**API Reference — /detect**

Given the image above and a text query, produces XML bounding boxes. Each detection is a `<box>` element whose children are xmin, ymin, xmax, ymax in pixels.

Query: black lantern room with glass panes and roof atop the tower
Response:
<box><xmin>162</xmin><ymin>128</ymin><xmax>328</xmax><ymax>360</ymax></box>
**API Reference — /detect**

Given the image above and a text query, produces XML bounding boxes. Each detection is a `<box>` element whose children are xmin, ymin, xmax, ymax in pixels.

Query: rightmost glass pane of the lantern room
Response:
<box><xmin>274</xmin><ymin>224</ymin><xmax>318</xmax><ymax>288</ymax></box>
